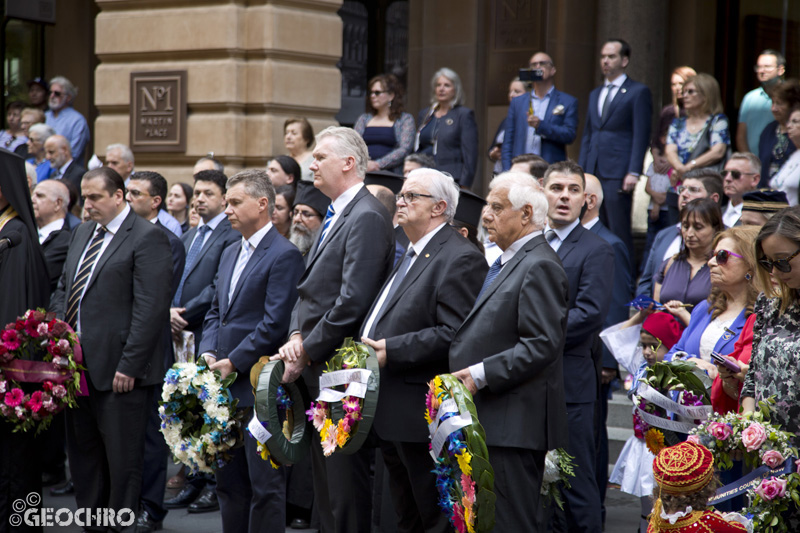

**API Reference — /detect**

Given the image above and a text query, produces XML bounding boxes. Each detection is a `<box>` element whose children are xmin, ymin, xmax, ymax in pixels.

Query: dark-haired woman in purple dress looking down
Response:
<box><xmin>653</xmin><ymin>198</ymin><xmax>724</xmax><ymax>325</ymax></box>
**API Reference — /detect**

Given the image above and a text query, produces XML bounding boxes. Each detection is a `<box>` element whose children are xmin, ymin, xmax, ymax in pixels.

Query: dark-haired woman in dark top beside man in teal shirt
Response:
<box><xmin>758</xmin><ymin>80</ymin><xmax>800</xmax><ymax>180</ymax></box>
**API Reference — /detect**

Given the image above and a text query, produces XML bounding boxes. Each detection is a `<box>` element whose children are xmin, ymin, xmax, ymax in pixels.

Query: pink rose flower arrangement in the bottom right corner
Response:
<box><xmin>689</xmin><ymin>398</ymin><xmax>800</xmax><ymax>533</ymax></box>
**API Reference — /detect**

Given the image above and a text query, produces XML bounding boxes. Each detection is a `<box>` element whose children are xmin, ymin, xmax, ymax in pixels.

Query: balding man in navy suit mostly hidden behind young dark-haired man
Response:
<box><xmin>581</xmin><ymin>174</ymin><xmax>633</xmax><ymax>522</ymax></box>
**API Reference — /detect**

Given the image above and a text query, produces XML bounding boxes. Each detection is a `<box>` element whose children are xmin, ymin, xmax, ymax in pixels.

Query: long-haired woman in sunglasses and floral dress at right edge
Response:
<box><xmin>741</xmin><ymin>207</ymin><xmax>800</xmax><ymax>448</ymax></box>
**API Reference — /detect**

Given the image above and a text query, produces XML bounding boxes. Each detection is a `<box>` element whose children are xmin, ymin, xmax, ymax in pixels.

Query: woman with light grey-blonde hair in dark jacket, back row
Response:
<box><xmin>414</xmin><ymin>68</ymin><xmax>478</xmax><ymax>189</ymax></box>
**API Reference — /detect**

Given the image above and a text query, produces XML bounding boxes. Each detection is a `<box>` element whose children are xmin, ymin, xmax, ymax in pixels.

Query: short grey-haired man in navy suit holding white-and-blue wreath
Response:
<box><xmin>200</xmin><ymin>170</ymin><xmax>303</xmax><ymax>533</ymax></box>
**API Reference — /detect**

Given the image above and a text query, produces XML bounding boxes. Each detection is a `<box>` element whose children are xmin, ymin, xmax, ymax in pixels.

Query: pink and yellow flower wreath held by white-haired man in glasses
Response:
<box><xmin>306</xmin><ymin>337</ymin><xmax>380</xmax><ymax>457</ymax></box>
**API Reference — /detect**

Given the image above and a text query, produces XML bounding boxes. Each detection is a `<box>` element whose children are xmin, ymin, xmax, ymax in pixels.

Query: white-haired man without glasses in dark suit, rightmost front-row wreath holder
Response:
<box><xmin>450</xmin><ymin>172</ymin><xmax>568</xmax><ymax>532</ymax></box>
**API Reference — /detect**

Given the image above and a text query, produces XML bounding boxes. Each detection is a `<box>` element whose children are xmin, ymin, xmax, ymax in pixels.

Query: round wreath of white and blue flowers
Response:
<box><xmin>158</xmin><ymin>361</ymin><xmax>242</xmax><ymax>473</ymax></box>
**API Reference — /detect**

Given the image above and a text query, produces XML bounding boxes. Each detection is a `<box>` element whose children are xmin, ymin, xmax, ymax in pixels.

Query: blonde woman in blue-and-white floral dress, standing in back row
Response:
<box><xmin>664</xmin><ymin>73</ymin><xmax>731</xmax><ymax>186</ymax></box>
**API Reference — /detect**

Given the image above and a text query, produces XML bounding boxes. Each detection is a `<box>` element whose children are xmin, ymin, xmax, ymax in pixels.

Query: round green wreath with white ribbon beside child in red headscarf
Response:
<box><xmin>632</xmin><ymin>360</ymin><xmax>712</xmax><ymax>455</ymax></box>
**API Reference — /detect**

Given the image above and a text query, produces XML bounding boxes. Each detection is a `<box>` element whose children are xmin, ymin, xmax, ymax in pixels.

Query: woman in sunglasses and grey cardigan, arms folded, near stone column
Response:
<box><xmin>353</xmin><ymin>74</ymin><xmax>414</xmax><ymax>174</ymax></box>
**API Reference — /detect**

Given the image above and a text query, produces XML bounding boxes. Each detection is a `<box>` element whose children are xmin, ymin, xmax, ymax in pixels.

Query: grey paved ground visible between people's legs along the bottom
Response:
<box><xmin>37</xmin><ymin>466</ymin><xmax>639</xmax><ymax>533</ymax></box>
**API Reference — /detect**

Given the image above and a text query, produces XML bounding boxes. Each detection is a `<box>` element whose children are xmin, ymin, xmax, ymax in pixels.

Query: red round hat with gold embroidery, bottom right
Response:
<box><xmin>653</xmin><ymin>442</ymin><xmax>714</xmax><ymax>494</ymax></box>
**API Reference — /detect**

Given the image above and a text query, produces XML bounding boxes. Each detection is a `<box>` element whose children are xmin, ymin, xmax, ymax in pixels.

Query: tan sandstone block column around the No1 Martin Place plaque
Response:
<box><xmin>94</xmin><ymin>0</ymin><xmax>342</xmax><ymax>182</ymax></box>
